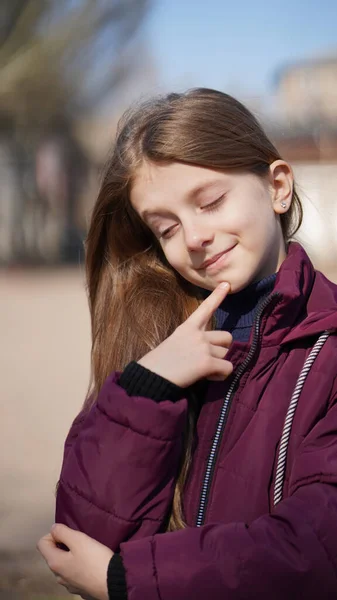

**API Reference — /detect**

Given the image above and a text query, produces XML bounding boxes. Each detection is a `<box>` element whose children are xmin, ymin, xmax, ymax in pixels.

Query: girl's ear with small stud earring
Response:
<box><xmin>269</xmin><ymin>160</ymin><xmax>294</xmax><ymax>215</ymax></box>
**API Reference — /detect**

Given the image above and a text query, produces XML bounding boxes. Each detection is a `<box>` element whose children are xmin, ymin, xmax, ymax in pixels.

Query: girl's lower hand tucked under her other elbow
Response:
<box><xmin>37</xmin><ymin>525</ymin><xmax>113</xmax><ymax>600</ymax></box>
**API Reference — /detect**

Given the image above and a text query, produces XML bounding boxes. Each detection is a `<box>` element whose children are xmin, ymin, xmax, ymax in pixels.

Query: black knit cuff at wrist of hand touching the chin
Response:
<box><xmin>119</xmin><ymin>361</ymin><xmax>186</xmax><ymax>402</ymax></box>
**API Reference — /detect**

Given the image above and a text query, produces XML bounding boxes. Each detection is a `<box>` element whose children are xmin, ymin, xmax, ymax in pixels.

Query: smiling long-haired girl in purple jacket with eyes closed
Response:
<box><xmin>39</xmin><ymin>89</ymin><xmax>337</xmax><ymax>600</ymax></box>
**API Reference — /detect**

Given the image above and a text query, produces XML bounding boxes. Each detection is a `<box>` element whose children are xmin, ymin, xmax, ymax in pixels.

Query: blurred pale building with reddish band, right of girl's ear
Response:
<box><xmin>267</xmin><ymin>51</ymin><xmax>337</xmax><ymax>281</ymax></box>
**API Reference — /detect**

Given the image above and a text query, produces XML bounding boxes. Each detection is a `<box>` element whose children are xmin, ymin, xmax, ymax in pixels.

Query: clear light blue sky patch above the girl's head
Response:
<box><xmin>145</xmin><ymin>0</ymin><xmax>337</xmax><ymax>96</ymax></box>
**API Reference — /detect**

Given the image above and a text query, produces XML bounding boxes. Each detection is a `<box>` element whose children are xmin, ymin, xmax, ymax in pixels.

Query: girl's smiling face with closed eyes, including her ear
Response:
<box><xmin>131</xmin><ymin>160</ymin><xmax>292</xmax><ymax>293</ymax></box>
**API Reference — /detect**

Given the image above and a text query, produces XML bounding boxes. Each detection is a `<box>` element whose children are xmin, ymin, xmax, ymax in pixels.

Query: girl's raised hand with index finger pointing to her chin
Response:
<box><xmin>138</xmin><ymin>283</ymin><xmax>233</xmax><ymax>387</ymax></box>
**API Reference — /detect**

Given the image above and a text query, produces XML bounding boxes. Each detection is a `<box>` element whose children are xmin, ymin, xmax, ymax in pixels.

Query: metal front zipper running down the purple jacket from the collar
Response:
<box><xmin>196</xmin><ymin>292</ymin><xmax>280</xmax><ymax>527</ymax></box>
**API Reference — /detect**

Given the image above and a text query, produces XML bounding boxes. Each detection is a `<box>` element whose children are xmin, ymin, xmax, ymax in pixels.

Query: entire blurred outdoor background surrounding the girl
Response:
<box><xmin>0</xmin><ymin>0</ymin><xmax>337</xmax><ymax>600</ymax></box>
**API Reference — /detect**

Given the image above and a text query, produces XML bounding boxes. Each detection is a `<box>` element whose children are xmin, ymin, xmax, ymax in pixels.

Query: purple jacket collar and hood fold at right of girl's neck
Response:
<box><xmin>262</xmin><ymin>242</ymin><xmax>337</xmax><ymax>346</ymax></box>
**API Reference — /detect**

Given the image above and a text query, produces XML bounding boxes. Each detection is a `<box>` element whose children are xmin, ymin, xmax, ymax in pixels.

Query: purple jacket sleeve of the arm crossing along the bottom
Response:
<box><xmin>121</xmin><ymin>396</ymin><xmax>337</xmax><ymax>600</ymax></box>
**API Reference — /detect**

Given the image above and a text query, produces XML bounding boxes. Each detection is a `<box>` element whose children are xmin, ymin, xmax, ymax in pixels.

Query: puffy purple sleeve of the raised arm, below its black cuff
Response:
<box><xmin>56</xmin><ymin>373</ymin><xmax>187</xmax><ymax>551</ymax></box>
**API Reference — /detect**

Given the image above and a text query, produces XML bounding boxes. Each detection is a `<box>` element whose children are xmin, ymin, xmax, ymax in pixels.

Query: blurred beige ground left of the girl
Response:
<box><xmin>0</xmin><ymin>269</ymin><xmax>90</xmax><ymax>591</ymax></box>
